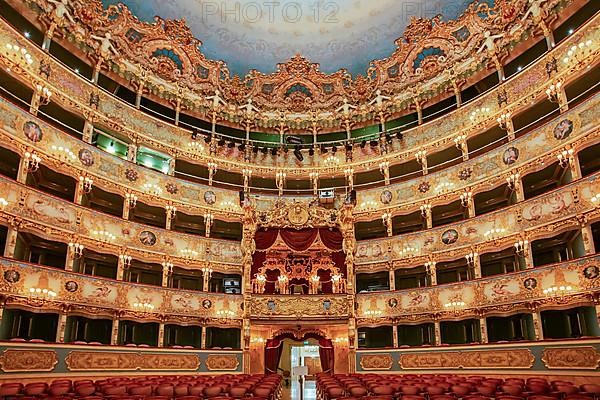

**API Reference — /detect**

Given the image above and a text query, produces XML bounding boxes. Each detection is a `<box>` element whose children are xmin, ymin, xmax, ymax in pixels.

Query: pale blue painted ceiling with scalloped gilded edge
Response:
<box><xmin>102</xmin><ymin>0</ymin><xmax>478</xmax><ymax>76</ymax></box>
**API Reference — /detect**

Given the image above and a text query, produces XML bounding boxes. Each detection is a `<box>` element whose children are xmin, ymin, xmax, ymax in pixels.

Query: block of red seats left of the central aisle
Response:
<box><xmin>0</xmin><ymin>374</ymin><xmax>281</xmax><ymax>400</ymax></box>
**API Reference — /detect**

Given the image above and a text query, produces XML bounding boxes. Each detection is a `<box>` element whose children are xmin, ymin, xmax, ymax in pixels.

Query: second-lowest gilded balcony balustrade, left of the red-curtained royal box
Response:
<box><xmin>0</xmin><ymin>178</ymin><xmax>241</xmax><ymax>273</ymax></box>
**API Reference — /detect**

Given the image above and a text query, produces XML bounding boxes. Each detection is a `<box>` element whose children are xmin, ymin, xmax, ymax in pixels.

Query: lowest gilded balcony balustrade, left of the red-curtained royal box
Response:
<box><xmin>0</xmin><ymin>258</ymin><xmax>243</xmax><ymax>326</ymax></box>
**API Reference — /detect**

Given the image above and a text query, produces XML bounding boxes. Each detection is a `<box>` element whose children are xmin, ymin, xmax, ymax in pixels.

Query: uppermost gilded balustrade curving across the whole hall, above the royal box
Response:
<box><xmin>0</xmin><ymin>16</ymin><xmax>600</xmax><ymax>178</ymax></box>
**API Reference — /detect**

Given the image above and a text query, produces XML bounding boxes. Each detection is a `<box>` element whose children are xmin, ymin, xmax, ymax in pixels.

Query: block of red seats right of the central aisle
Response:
<box><xmin>317</xmin><ymin>374</ymin><xmax>600</xmax><ymax>400</ymax></box>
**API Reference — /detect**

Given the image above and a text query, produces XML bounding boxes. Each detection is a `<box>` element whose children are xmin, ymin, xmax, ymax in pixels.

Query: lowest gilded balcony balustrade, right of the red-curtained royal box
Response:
<box><xmin>356</xmin><ymin>255</ymin><xmax>600</xmax><ymax>326</ymax></box>
